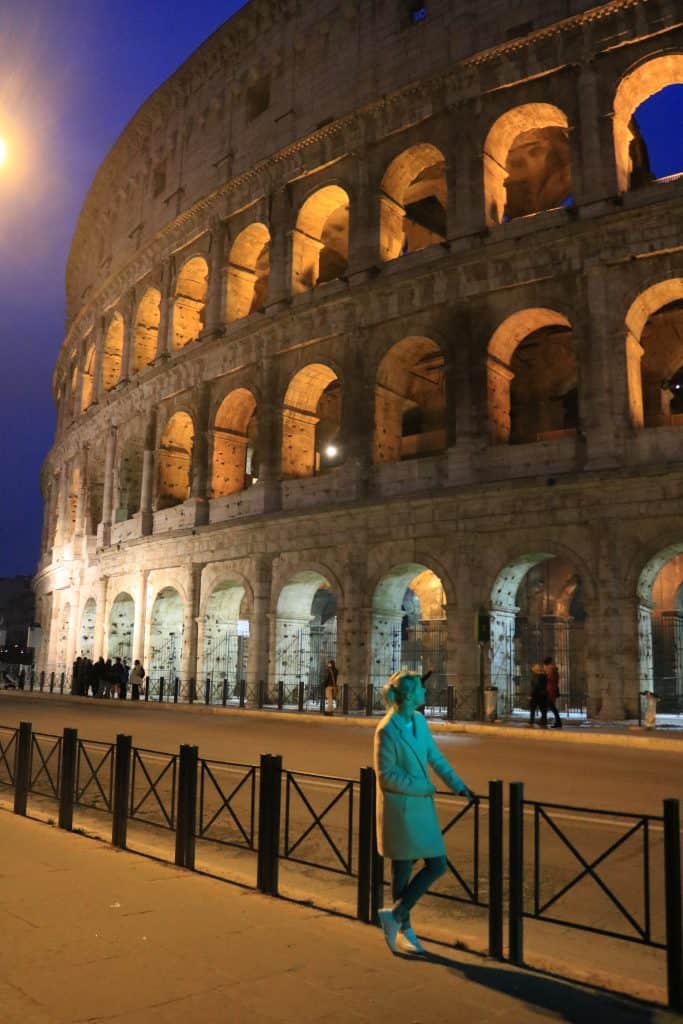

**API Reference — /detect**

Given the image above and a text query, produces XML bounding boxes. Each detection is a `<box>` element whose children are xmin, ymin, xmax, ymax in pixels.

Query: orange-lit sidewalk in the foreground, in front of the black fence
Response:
<box><xmin>0</xmin><ymin>810</ymin><xmax>680</xmax><ymax>1024</ymax></box>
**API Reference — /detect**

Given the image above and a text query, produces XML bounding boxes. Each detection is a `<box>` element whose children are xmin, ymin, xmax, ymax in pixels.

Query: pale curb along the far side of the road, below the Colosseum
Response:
<box><xmin>0</xmin><ymin>690</ymin><xmax>683</xmax><ymax>754</ymax></box>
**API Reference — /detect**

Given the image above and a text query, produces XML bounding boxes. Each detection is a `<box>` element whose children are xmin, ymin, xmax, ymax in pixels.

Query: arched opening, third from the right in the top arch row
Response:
<box><xmin>380</xmin><ymin>143</ymin><xmax>449</xmax><ymax>260</ymax></box>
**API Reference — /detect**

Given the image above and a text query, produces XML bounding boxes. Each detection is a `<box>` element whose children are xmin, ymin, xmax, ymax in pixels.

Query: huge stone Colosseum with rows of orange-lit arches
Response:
<box><xmin>34</xmin><ymin>0</ymin><xmax>683</xmax><ymax>719</ymax></box>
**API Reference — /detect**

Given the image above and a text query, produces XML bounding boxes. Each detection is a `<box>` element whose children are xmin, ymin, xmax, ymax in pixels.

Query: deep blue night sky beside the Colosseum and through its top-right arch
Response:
<box><xmin>0</xmin><ymin>0</ymin><xmax>683</xmax><ymax>577</ymax></box>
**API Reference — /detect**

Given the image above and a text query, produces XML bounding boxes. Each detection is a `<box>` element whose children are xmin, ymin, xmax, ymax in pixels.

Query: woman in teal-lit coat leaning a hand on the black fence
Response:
<box><xmin>375</xmin><ymin>672</ymin><xmax>473</xmax><ymax>953</ymax></box>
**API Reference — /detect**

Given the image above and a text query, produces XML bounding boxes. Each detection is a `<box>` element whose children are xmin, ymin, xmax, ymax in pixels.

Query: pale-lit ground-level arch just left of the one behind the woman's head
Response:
<box><xmin>274</xmin><ymin>569</ymin><xmax>337</xmax><ymax>708</ymax></box>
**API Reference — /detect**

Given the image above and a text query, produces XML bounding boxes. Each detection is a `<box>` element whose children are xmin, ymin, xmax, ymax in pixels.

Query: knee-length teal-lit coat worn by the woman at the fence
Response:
<box><xmin>375</xmin><ymin>711</ymin><xmax>467</xmax><ymax>860</ymax></box>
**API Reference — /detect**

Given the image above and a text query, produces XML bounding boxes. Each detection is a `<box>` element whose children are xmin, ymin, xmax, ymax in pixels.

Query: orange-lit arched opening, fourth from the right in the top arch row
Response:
<box><xmin>292</xmin><ymin>185</ymin><xmax>349</xmax><ymax>295</ymax></box>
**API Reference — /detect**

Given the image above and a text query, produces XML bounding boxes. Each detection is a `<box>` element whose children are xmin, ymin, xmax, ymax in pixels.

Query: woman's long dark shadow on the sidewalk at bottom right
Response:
<box><xmin>405</xmin><ymin>952</ymin><xmax>680</xmax><ymax>1024</ymax></box>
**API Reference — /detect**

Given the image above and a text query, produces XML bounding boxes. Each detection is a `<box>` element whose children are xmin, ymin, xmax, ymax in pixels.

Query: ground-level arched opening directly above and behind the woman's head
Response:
<box><xmin>370</xmin><ymin>562</ymin><xmax>447</xmax><ymax>714</ymax></box>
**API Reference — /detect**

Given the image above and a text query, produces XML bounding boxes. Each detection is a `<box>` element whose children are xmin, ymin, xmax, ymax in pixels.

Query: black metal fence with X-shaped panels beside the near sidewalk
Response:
<box><xmin>0</xmin><ymin>722</ymin><xmax>683</xmax><ymax>1011</ymax></box>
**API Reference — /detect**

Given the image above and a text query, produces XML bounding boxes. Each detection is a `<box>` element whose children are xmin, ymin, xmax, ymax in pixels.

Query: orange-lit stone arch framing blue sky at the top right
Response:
<box><xmin>612</xmin><ymin>53</ymin><xmax>683</xmax><ymax>193</ymax></box>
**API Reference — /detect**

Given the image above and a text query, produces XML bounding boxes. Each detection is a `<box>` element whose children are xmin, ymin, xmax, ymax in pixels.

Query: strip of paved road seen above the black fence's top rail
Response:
<box><xmin>0</xmin><ymin>691</ymin><xmax>683</xmax><ymax>814</ymax></box>
